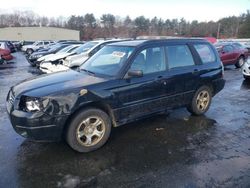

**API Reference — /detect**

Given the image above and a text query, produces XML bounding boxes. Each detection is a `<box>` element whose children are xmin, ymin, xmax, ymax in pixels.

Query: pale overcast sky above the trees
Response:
<box><xmin>0</xmin><ymin>0</ymin><xmax>250</xmax><ymax>21</ymax></box>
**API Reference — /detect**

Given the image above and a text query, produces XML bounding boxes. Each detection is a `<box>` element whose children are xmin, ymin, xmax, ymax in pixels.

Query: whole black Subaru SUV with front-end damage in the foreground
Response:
<box><xmin>7</xmin><ymin>39</ymin><xmax>225</xmax><ymax>152</ymax></box>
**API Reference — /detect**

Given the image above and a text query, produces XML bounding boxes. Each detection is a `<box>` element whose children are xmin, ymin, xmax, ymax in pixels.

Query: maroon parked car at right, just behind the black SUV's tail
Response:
<box><xmin>215</xmin><ymin>43</ymin><xmax>248</xmax><ymax>68</ymax></box>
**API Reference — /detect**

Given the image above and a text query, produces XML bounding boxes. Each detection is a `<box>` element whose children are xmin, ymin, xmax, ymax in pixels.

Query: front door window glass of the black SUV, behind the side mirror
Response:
<box><xmin>130</xmin><ymin>47</ymin><xmax>166</xmax><ymax>74</ymax></box>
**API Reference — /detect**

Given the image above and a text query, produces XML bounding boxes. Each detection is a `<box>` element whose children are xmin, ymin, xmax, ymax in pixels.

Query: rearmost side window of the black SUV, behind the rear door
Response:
<box><xmin>194</xmin><ymin>44</ymin><xmax>215</xmax><ymax>63</ymax></box>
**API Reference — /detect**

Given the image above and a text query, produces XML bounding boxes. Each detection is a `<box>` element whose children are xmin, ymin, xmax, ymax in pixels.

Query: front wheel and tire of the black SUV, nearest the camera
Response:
<box><xmin>66</xmin><ymin>108</ymin><xmax>111</xmax><ymax>153</ymax></box>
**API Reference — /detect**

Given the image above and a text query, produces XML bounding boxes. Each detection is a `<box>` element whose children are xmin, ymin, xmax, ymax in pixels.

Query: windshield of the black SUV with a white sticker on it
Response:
<box><xmin>80</xmin><ymin>46</ymin><xmax>134</xmax><ymax>77</ymax></box>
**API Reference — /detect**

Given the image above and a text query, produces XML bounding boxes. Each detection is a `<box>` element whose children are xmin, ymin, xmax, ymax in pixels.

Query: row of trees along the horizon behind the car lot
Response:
<box><xmin>0</xmin><ymin>10</ymin><xmax>250</xmax><ymax>40</ymax></box>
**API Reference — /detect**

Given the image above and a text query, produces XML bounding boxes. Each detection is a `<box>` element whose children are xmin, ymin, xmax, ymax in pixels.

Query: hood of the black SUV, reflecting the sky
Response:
<box><xmin>12</xmin><ymin>70</ymin><xmax>106</xmax><ymax>97</ymax></box>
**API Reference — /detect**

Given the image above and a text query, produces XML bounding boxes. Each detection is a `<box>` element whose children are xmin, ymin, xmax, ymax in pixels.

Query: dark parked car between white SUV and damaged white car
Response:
<box><xmin>27</xmin><ymin>44</ymin><xmax>69</xmax><ymax>66</ymax></box>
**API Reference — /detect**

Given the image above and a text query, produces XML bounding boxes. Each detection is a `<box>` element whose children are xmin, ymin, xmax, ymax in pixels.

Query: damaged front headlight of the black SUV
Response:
<box><xmin>24</xmin><ymin>97</ymin><xmax>49</xmax><ymax>112</ymax></box>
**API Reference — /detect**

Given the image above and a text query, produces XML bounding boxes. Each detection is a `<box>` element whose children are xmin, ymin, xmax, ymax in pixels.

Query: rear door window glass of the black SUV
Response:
<box><xmin>166</xmin><ymin>45</ymin><xmax>194</xmax><ymax>69</ymax></box>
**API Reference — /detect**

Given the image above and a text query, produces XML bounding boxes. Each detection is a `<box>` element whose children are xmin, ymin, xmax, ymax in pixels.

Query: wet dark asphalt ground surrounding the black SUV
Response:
<box><xmin>0</xmin><ymin>53</ymin><xmax>250</xmax><ymax>187</ymax></box>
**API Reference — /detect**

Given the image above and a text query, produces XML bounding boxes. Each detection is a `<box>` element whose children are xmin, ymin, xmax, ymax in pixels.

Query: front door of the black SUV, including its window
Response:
<box><xmin>113</xmin><ymin>47</ymin><xmax>166</xmax><ymax>121</ymax></box>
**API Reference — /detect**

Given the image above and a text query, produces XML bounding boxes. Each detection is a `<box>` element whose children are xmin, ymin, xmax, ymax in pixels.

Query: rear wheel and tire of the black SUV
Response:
<box><xmin>187</xmin><ymin>86</ymin><xmax>212</xmax><ymax>116</ymax></box>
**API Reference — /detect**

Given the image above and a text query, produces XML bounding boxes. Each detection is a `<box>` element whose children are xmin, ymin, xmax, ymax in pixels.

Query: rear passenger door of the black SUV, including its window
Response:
<box><xmin>166</xmin><ymin>44</ymin><xmax>200</xmax><ymax>107</ymax></box>
